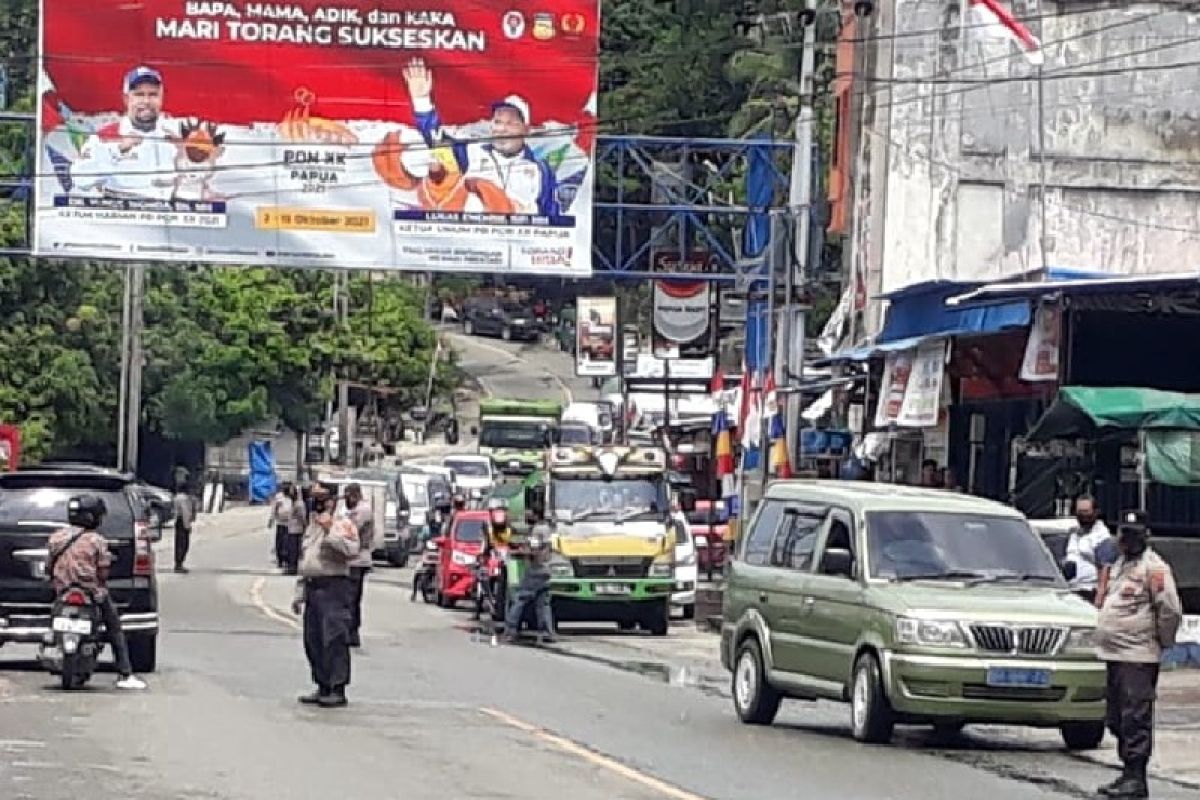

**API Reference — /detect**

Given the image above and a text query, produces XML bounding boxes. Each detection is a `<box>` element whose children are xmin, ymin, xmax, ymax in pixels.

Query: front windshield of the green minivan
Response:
<box><xmin>866</xmin><ymin>511</ymin><xmax>1063</xmax><ymax>585</ymax></box>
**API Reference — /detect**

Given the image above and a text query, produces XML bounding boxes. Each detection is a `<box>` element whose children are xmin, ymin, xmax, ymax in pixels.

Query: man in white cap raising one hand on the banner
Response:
<box><xmin>404</xmin><ymin>59</ymin><xmax>559</xmax><ymax>216</ymax></box>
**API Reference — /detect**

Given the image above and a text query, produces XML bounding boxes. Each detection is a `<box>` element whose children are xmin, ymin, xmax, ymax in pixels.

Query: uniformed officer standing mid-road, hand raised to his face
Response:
<box><xmin>292</xmin><ymin>486</ymin><xmax>359</xmax><ymax>708</ymax></box>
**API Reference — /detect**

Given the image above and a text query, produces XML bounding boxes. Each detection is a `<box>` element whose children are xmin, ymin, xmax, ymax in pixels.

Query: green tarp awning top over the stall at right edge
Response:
<box><xmin>1028</xmin><ymin>386</ymin><xmax>1200</xmax><ymax>441</ymax></box>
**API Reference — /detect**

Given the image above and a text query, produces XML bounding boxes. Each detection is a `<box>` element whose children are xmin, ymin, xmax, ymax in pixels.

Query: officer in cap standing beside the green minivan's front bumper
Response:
<box><xmin>1096</xmin><ymin>511</ymin><xmax>1183</xmax><ymax>799</ymax></box>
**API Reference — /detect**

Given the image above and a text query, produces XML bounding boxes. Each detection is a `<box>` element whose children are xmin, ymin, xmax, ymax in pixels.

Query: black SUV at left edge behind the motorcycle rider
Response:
<box><xmin>0</xmin><ymin>465</ymin><xmax>161</xmax><ymax>673</ymax></box>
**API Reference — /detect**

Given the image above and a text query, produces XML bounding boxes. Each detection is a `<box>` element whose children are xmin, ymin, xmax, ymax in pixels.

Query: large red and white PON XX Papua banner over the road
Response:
<box><xmin>35</xmin><ymin>0</ymin><xmax>600</xmax><ymax>276</ymax></box>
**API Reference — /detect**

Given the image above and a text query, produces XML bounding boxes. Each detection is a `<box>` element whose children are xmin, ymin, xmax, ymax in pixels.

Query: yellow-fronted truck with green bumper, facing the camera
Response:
<box><xmin>526</xmin><ymin>446</ymin><xmax>689</xmax><ymax>636</ymax></box>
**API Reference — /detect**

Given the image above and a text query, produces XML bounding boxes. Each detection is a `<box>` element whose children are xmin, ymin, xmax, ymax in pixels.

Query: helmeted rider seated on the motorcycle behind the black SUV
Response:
<box><xmin>47</xmin><ymin>494</ymin><xmax>146</xmax><ymax>690</ymax></box>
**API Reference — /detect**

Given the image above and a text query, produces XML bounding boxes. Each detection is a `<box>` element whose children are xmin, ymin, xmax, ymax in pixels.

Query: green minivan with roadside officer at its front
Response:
<box><xmin>721</xmin><ymin>481</ymin><xmax>1105</xmax><ymax>750</ymax></box>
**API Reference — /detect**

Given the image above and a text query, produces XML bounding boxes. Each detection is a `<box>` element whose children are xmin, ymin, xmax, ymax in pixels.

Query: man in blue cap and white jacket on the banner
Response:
<box><xmin>71</xmin><ymin>66</ymin><xmax>179</xmax><ymax>200</ymax></box>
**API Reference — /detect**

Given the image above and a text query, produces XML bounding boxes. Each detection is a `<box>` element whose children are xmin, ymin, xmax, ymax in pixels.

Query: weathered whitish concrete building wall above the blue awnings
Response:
<box><xmin>830</xmin><ymin>0</ymin><xmax>1200</xmax><ymax>341</ymax></box>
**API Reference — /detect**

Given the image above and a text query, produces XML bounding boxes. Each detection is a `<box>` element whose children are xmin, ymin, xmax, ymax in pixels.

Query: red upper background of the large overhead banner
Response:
<box><xmin>42</xmin><ymin>0</ymin><xmax>599</xmax><ymax>126</ymax></box>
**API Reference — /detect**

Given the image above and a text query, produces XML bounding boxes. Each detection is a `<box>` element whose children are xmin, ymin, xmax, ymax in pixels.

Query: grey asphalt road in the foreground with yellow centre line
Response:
<box><xmin>0</xmin><ymin>510</ymin><xmax>1187</xmax><ymax>800</ymax></box>
